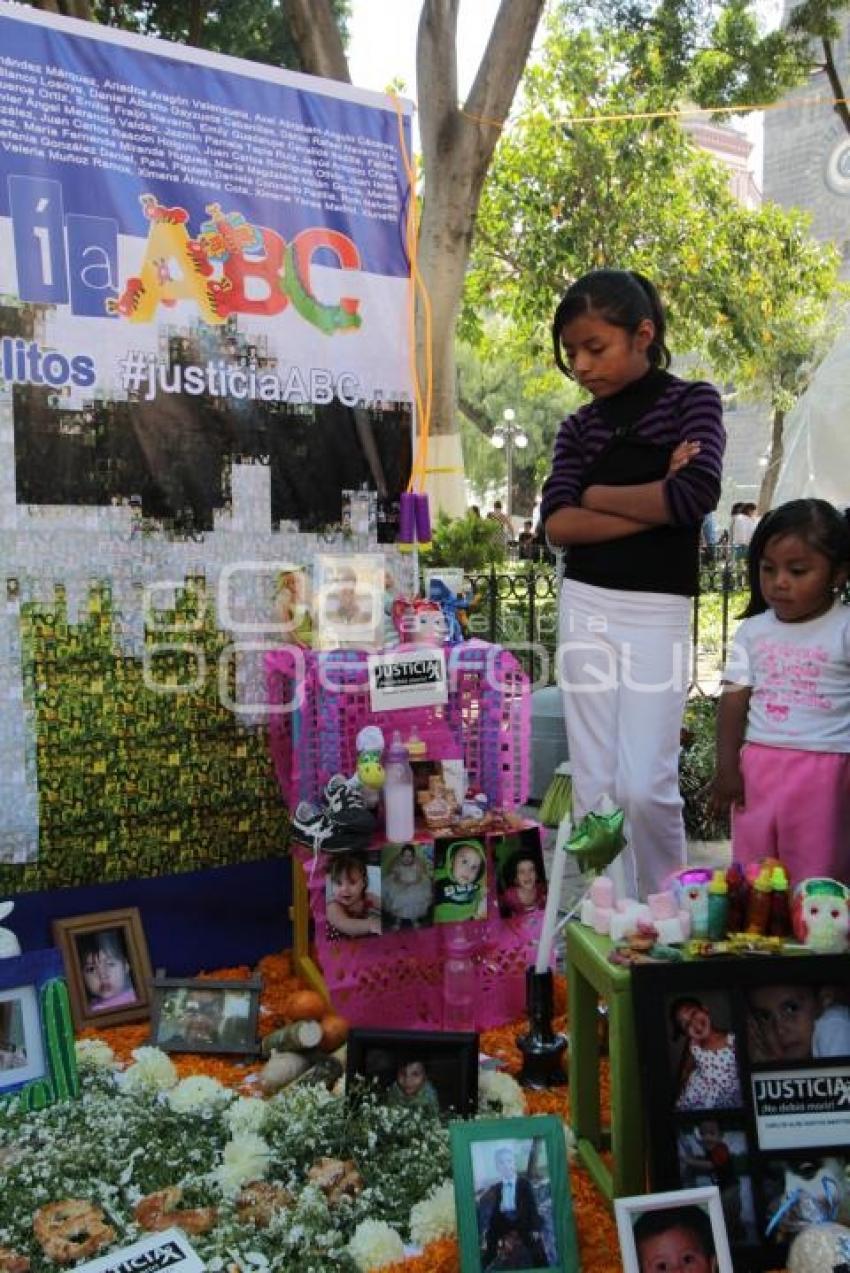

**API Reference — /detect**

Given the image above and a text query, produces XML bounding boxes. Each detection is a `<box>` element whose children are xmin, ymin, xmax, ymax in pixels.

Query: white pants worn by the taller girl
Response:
<box><xmin>557</xmin><ymin>579</ymin><xmax>691</xmax><ymax>897</ymax></box>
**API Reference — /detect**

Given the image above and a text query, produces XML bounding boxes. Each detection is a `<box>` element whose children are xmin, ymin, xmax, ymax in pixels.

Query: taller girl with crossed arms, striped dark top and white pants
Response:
<box><xmin>541</xmin><ymin>270</ymin><xmax>725</xmax><ymax>897</ymax></box>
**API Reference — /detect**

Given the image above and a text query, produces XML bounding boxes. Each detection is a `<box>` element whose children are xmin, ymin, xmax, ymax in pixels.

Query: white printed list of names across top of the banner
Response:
<box><xmin>0</xmin><ymin>56</ymin><xmax>400</xmax><ymax>222</ymax></box>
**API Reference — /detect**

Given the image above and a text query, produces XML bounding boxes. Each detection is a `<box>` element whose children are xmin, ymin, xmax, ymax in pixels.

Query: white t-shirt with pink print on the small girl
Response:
<box><xmin>723</xmin><ymin>601</ymin><xmax>850</xmax><ymax>752</ymax></box>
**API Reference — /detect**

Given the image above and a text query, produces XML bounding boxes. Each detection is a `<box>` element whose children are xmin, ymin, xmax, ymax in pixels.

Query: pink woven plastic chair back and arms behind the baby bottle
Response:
<box><xmin>266</xmin><ymin>640</ymin><xmax>531</xmax><ymax>808</ymax></box>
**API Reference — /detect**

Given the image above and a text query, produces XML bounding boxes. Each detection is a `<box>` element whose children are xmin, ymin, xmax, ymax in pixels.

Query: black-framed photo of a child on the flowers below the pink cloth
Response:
<box><xmin>346</xmin><ymin>1027</ymin><xmax>478</xmax><ymax>1118</ymax></box>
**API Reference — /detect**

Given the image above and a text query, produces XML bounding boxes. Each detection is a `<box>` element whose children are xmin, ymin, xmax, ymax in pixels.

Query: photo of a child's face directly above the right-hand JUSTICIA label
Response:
<box><xmin>747</xmin><ymin>985</ymin><xmax>850</xmax><ymax>1062</ymax></box>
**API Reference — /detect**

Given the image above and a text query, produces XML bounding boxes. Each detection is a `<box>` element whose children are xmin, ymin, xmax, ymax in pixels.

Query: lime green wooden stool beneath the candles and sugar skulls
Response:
<box><xmin>566</xmin><ymin>923</ymin><xmax>646</xmax><ymax>1202</ymax></box>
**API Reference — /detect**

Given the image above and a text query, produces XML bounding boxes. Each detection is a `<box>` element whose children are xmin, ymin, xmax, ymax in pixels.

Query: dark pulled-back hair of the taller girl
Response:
<box><xmin>552</xmin><ymin>270</ymin><xmax>671</xmax><ymax>379</ymax></box>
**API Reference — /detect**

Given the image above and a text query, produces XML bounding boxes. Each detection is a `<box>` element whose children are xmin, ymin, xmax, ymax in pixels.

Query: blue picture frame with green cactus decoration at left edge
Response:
<box><xmin>0</xmin><ymin>950</ymin><xmax>79</xmax><ymax>1109</ymax></box>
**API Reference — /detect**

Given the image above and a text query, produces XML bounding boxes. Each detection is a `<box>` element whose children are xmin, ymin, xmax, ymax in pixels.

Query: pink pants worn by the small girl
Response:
<box><xmin>732</xmin><ymin>742</ymin><xmax>850</xmax><ymax>886</ymax></box>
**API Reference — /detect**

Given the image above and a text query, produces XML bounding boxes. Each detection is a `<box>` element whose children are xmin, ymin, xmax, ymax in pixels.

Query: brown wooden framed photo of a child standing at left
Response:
<box><xmin>52</xmin><ymin>906</ymin><xmax>150</xmax><ymax>1030</ymax></box>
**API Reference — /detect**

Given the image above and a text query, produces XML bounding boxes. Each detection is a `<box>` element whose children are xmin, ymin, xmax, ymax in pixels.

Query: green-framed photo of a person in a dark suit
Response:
<box><xmin>449</xmin><ymin>1114</ymin><xmax>579</xmax><ymax>1273</ymax></box>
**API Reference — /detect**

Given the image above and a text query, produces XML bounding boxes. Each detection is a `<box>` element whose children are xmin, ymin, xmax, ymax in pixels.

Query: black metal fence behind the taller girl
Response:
<box><xmin>458</xmin><ymin>550</ymin><xmax>747</xmax><ymax>694</ymax></box>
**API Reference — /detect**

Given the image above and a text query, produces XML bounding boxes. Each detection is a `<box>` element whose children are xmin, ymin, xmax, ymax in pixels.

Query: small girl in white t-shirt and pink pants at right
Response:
<box><xmin>711</xmin><ymin>499</ymin><xmax>850</xmax><ymax>883</ymax></box>
